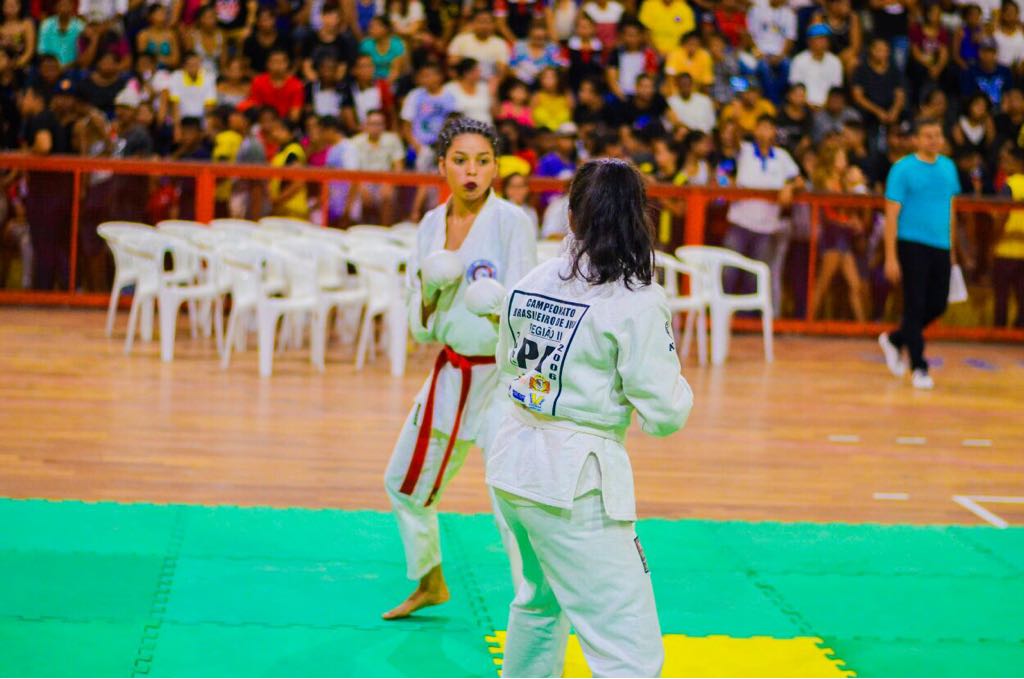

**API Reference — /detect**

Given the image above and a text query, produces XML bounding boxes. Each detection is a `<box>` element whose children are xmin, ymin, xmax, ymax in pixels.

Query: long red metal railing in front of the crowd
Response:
<box><xmin>0</xmin><ymin>154</ymin><xmax>1024</xmax><ymax>341</ymax></box>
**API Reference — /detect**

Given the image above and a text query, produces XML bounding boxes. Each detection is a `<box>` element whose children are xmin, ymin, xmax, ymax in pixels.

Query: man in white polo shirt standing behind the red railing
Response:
<box><xmin>723</xmin><ymin>116</ymin><xmax>803</xmax><ymax>312</ymax></box>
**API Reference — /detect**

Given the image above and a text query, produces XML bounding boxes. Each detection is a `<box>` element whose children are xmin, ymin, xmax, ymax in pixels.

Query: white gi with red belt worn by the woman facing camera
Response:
<box><xmin>385</xmin><ymin>192</ymin><xmax>537</xmax><ymax>580</ymax></box>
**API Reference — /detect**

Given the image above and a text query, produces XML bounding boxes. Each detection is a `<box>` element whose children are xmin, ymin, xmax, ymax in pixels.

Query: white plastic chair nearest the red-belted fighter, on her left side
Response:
<box><xmin>349</xmin><ymin>242</ymin><xmax>410</xmax><ymax>377</ymax></box>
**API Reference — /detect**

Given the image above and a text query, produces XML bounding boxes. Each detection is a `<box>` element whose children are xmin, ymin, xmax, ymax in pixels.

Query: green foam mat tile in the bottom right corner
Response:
<box><xmin>826</xmin><ymin>637</ymin><xmax>1024</xmax><ymax>677</ymax></box>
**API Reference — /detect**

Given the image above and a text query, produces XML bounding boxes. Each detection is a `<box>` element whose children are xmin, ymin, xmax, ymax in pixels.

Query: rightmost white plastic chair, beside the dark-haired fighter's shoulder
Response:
<box><xmin>676</xmin><ymin>246</ymin><xmax>774</xmax><ymax>366</ymax></box>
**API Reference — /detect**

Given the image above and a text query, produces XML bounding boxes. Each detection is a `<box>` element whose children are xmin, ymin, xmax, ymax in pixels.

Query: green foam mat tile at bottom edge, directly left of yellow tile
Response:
<box><xmin>150</xmin><ymin>623</ymin><xmax>495</xmax><ymax>677</ymax></box>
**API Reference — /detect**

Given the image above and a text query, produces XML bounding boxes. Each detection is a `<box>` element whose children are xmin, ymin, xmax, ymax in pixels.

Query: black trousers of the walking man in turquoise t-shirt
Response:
<box><xmin>889</xmin><ymin>241</ymin><xmax>951</xmax><ymax>372</ymax></box>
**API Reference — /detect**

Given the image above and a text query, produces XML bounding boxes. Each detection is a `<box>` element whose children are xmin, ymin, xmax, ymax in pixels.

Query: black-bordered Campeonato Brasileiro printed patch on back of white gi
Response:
<box><xmin>507</xmin><ymin>290</ymin><xmax>590</xmax><ymax>416</ymax></box>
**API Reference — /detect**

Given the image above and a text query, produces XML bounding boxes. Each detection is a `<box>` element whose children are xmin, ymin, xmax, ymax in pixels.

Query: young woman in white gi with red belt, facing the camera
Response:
<box><xmin>384</xmin><ymin>118</ymin><xmax>537</xmax><ymax>620</ymax></box>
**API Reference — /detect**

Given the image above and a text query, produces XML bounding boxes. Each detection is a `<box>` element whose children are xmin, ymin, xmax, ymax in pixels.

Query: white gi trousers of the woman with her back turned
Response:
<box><xmin>495</xmin><ymin>490</ymin><xmax>665</xmax><ymax>677</ymax></box>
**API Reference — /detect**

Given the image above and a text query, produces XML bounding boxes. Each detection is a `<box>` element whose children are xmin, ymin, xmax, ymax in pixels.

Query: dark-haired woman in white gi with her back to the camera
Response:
<box><xmin>487</xmin><ymin>160</ymin><xmax>693</xmax><ymax>677</ymax></box>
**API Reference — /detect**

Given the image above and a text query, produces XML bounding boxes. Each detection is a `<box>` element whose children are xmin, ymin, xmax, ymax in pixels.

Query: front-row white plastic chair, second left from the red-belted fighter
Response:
<box><xmin>221</xmin><ymin>243</ymin><xmax>324</xmax><ymax>377</ymax></box>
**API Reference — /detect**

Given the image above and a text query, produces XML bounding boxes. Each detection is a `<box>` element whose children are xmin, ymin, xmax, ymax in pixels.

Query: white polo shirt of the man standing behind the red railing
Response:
<box><xmin>728</xmin><ymin>141</ymin><xmax>800</xmax><ymax>234</ymax></box>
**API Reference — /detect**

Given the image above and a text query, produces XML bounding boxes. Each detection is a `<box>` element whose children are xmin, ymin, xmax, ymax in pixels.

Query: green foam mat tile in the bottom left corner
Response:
<box><xmin>0</xmin><ymin>619</ymin><xmax>143</xmax><ymax>677</ymax></box>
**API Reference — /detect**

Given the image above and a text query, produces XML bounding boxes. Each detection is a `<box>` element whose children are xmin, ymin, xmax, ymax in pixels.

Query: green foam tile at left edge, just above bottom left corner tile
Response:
<box><xmin>0</xmin><ymin>551</ymin><xmax>164</xmax><ymax>622</ymax></box>
